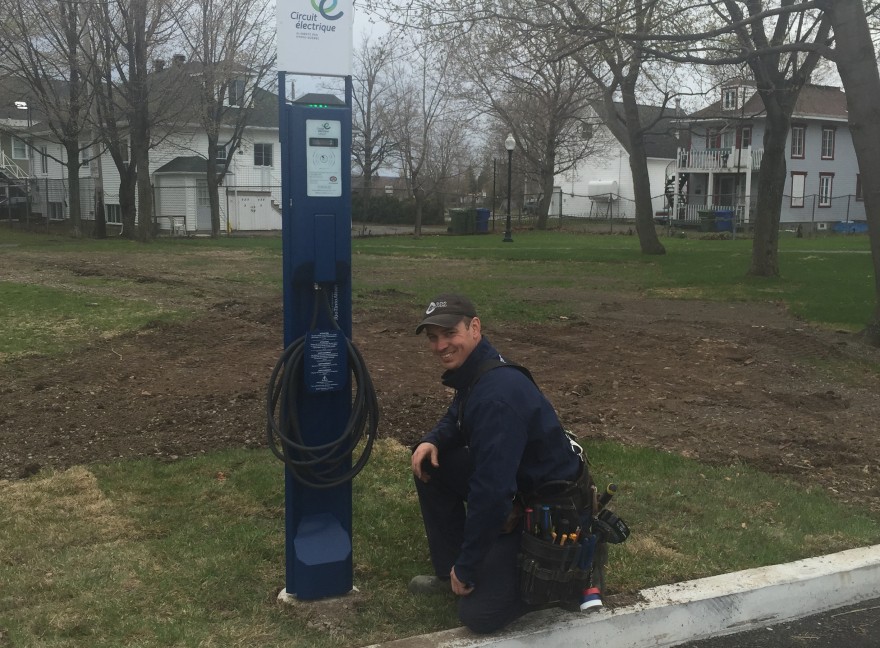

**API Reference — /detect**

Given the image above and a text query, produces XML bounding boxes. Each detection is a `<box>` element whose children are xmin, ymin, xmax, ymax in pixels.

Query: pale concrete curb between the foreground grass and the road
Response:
<box><xmin>368</xmin><ymin>545</ymin><xmax>880</xmax><ymax>648</ymax></box>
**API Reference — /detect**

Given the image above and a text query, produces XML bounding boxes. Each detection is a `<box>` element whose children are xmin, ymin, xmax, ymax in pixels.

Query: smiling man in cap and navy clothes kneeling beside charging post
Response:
<box><xmin>410</xmin><ymin>293</ymin><xmax>586</xmax><ymax>633</ymax></box>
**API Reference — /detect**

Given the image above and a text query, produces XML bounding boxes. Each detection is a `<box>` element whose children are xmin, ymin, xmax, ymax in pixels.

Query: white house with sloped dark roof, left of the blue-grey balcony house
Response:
<box><xmin>551</xmin><ymin>106</ymin><xmax>681</xmax><ymax>218</ymax></box>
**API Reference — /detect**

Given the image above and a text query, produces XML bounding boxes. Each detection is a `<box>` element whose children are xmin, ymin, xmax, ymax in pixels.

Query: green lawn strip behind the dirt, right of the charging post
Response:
<box><xmin>354</xmin><ymin>232</ymin><xmax>876</xmax><ymax>331</ymax></box>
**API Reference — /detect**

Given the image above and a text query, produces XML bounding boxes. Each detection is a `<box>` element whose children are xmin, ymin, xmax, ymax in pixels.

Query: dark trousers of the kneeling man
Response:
<box><xmin>415</xmin><ymin>448</ymin><xmax>528</xmax><ymax>633</ymax></box>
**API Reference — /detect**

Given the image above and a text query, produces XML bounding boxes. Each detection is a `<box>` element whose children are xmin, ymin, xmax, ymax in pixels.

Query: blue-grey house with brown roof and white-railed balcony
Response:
<box><xmin>666</xmin><ymin>81</ymin><xmax>865</xmax><ymax>230</ymax></box>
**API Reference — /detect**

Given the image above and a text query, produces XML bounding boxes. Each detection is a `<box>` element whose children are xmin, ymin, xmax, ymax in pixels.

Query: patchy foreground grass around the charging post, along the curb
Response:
<box><xmin>0</xmin><ymin>440</ymin><xmax>880</xmax><ymax>648</ymax></box>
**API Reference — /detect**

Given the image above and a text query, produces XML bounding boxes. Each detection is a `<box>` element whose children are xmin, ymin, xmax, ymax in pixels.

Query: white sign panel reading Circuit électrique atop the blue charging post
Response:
<box><xmin>277</xmin><ymin>0</ymin><xmax>354</xmax><ymax>76</ymax></box>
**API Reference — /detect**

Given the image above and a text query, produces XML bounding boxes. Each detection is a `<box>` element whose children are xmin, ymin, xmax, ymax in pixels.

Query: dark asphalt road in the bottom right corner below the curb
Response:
<box><xmin>678</xmin><ymin>599</ymin><xmax>880</xmax><ymax>648</ymax></box>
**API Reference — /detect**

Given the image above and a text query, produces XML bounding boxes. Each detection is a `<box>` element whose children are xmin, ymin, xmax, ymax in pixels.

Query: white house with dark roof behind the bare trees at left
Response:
<box><xmin>0</xmin><ymin>61</ymin><xmax>281</xmax><ymax>235</ymax></box>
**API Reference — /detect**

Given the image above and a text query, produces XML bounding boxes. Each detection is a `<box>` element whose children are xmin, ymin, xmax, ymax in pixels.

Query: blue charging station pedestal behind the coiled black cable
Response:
<box><xmin>278</xmin><ymin>73</ymin><xmax>353</xmax><ymax>599</ymax></box>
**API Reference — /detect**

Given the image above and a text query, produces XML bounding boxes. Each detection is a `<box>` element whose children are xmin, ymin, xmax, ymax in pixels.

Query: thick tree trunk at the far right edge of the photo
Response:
<box><xmin>822</xmin><ymin>0</ymin><xmax>880</xmax><ymax>346</ymax></box>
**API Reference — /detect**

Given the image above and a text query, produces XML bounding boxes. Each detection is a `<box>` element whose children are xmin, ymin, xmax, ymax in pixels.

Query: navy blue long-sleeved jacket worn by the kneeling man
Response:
<box><xmin>422</xmin><ymin>337</ymin><xmax>580</xmax><ymax>583</ymax></box>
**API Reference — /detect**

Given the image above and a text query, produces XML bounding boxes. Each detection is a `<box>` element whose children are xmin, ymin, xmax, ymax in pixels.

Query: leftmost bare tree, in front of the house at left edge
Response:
<box><xmin>0</xmin><ymin>0</ymin><xmax>94</xmax><ymax>236</ymax></box>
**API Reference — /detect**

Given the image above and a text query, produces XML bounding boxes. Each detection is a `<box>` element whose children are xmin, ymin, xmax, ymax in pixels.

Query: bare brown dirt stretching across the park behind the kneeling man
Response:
<box><xmin>0</xmin><ymin>246</ymin><xmax>880</xmax><ymax>511</ymax></box>
